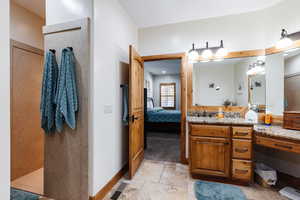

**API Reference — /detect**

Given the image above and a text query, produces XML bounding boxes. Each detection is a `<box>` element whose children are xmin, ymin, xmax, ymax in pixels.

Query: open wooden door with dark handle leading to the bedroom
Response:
<box><xmin>129</xmin><ymin>46</ymin><xmax>144</xmax><ymax>179</ymax></box>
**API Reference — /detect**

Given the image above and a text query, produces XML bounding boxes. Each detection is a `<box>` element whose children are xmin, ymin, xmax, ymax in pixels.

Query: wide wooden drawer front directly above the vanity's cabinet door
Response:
<box><xmin>190</xmin><ymin>124</ymin><xmax>230</xmax><ymax>138</ymax></box>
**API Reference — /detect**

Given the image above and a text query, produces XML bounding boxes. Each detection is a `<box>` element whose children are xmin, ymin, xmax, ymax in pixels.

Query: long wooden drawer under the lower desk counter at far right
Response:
<box><xmin>255</xmin><ymin>136</ymin><xmax>300</xmax><ymax>153</ymax></box>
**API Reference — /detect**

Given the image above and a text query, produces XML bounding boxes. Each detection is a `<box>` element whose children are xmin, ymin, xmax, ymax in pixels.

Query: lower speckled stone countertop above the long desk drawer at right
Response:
<box><xmin>254</xmin><ymin>124</ymin><xmax>300</xmax><ymax>141</ymax></box>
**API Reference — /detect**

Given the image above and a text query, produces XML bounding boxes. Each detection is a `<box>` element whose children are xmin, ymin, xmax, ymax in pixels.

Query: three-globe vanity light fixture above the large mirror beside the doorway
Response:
<box><xmin>189</xmin><ymin>40</ymin><xmax>228</xmax><ymax>63</ymax></box>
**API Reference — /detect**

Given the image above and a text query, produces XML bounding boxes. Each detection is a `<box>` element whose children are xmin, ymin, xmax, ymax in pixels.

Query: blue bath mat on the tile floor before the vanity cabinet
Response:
<box><xmin>194</xmin><ymin>181</ymin><xmax>247</xmax><ymax>200</ymax></box>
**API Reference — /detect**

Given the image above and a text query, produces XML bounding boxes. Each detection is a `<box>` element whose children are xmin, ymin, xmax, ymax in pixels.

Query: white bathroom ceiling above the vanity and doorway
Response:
<box><xmin>119</xmin><ymin>0</ymin><xmax>282</xmax><ymax>28</ymax></box>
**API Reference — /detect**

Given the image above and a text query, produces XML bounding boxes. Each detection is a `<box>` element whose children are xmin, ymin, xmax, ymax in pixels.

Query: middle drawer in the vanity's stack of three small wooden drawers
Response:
<box><xmin>232</xmin><ymin>139</ymin><xmax>252</xmax><ymax>160</ymax></box>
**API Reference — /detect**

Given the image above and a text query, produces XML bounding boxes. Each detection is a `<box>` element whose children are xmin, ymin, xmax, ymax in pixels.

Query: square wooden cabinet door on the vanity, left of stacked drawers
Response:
<box><xmin>190</xmin><ymin>137</ymin><xmax>230</xmax><ymax>177</ymax></box>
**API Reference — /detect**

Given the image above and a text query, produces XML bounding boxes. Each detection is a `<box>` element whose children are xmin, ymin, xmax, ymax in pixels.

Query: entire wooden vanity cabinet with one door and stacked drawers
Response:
<box><xmin>189</xmin><ymin>123</ymin><xmax>253</xmax><ymax>183</ymax></box>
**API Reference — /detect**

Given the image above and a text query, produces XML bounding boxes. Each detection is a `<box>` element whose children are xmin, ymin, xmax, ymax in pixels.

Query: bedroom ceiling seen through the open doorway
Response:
<box><xmin>144</xmin><ymin>59</ymin><xmax>181</xmax><ymax>75</ymax></box>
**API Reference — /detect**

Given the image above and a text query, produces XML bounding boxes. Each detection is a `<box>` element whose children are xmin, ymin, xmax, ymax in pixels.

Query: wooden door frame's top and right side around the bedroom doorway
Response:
<box><xmin>142</xmin><ymin>53</ymin><xmax>188</xmax><ymax>164</ymax></box>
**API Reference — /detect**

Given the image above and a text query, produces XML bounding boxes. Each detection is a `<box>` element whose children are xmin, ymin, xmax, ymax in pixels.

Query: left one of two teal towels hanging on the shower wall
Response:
<box><xmin>40</xmin><ymin>51</ymin><xmax>58</xmax><ymax>133</ymax></box>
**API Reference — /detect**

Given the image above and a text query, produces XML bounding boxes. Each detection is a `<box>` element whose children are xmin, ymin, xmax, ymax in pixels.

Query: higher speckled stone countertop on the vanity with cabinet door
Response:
<box><xmin>187</xmin><ymin>116</ymin><xmax>256</xmax><ymax>125</ymax></box>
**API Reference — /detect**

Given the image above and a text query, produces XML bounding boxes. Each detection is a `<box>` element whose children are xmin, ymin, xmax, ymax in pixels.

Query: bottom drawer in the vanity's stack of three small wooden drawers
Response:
<box><xmin>232</xmin><ymin>159</ymin><xmax>252</xmax><ymax>182</ymax></box>
